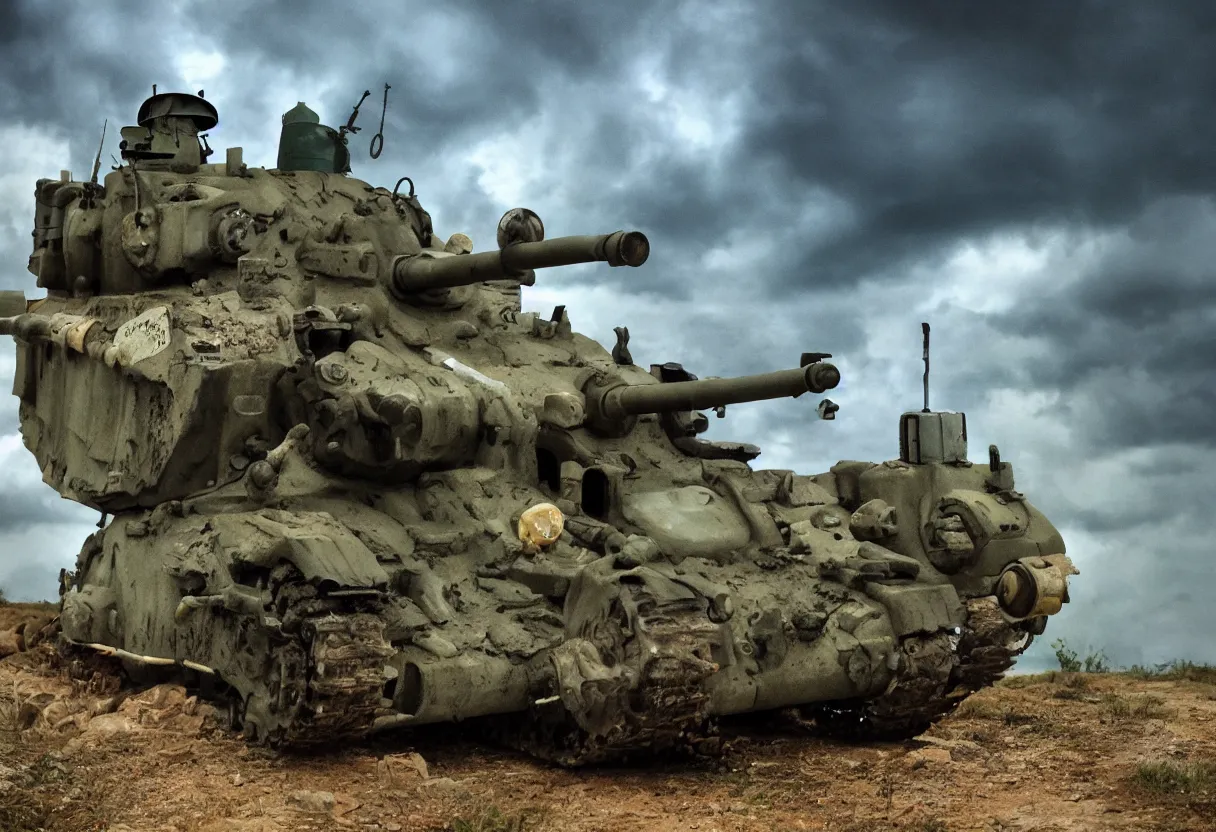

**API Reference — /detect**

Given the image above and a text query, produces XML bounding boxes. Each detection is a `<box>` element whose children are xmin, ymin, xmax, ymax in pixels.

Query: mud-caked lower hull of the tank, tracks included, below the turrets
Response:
<box><xmin>61</xmin><ymin>452</ymin><xmax>1058</xmax><ymax>765</ymax></box>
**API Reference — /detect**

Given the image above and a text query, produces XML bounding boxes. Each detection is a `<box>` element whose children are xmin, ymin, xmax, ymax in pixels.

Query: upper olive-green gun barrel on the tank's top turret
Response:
<box><xmin>393</xmin><ymin>231</ymin><xmax>651</xmax><ymax>294</ymax></box>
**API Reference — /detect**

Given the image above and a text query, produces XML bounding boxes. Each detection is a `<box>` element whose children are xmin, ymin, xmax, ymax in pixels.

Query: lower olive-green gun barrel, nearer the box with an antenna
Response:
<box><xmin>598</xmin><ymin>362</ymin><xmax>840</xmax><ymax>420</ymax></box>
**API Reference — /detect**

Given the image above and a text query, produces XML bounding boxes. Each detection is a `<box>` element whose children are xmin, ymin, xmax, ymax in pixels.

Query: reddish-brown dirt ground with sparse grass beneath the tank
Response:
<box><xmin>0</xmin><ymin>605</ymin><xmax>1216</xmax><ymax>832</ymax></box>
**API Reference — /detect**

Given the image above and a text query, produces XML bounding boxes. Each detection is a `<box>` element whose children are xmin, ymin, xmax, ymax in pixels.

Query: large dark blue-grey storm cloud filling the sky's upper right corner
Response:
<box><xmin>742</xmin><ymin>1</ymin><xmax>1216</xmax><ymax>291</ymax></box>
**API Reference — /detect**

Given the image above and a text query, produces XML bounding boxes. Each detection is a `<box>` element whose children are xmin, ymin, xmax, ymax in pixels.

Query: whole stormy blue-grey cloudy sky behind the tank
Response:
<box><xmin>0</xmin><ymin>0</ymin><xmax>1216</xmax><ymax>668</ymax></box>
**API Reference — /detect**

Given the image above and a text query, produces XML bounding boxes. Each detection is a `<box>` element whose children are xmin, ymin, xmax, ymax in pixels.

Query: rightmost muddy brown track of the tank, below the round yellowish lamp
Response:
<box><xmin>798</xmin><ymin>597</ymin><xmax>1034</xmax><ymax>741</ymax></box>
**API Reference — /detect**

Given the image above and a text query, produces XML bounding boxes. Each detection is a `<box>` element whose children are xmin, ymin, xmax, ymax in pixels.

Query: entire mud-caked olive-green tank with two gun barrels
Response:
<box><xmin>0</xmin><ymin>88</ymin><xmax>1075</xmax><ymax>765</ymax></box>
